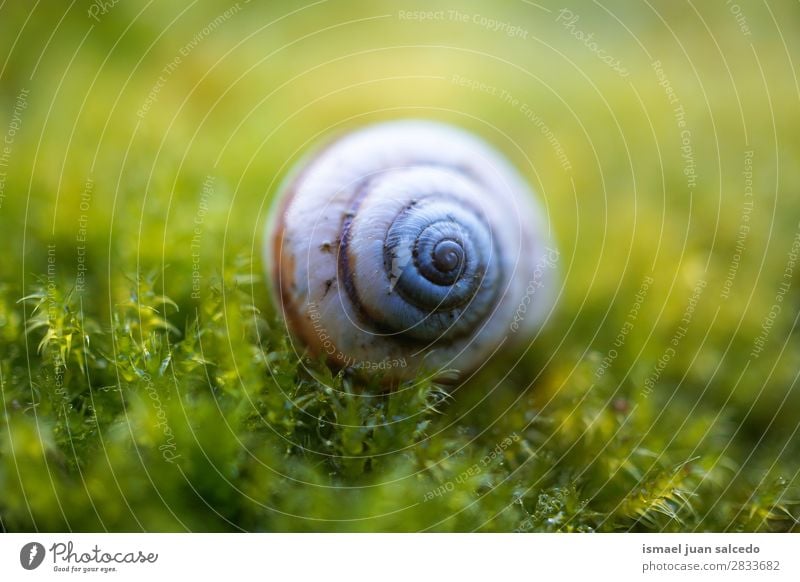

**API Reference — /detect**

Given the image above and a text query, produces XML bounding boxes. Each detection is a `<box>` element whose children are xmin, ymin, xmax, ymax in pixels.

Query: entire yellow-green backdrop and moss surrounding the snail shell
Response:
<box><xmin>0</xmin><ymin>0</ymin><xmax>800</xmax><ymax>531</ymax></box>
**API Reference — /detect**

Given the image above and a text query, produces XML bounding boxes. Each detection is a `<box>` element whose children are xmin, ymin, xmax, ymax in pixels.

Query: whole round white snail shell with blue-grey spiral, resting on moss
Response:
<box><xmin>264</xmin><ymin>120</ymin><xmax>558</xmax><ymax>382</ymax></box>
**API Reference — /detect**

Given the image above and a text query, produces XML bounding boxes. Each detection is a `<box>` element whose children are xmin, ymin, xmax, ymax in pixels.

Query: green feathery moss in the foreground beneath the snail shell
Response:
<box><xmin>0</xmin><ymin>262</ymin><xmax>797</xmax><ymax>531</ymax></box>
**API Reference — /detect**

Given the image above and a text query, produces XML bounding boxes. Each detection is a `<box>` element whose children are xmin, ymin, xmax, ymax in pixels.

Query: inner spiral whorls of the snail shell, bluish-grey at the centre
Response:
<box><xmin>339</xmin><ymin>166</ymin><xmax>501</xmax><ymax>342</ymax></box>
